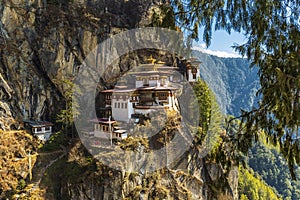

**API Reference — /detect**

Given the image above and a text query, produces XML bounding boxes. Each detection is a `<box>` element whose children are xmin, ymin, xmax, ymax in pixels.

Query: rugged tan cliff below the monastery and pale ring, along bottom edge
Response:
<box><xmin>42</xmin><ymin>139</ymin><xmax>238</xmax><ymax>200</ymax></box>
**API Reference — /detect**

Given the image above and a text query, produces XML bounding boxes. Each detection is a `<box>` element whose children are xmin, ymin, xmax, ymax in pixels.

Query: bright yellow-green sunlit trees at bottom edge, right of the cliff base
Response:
<box><xmin>238</xmin><ymin>166</ymin><xmax>280</xmax><ymax>200</ymax></box>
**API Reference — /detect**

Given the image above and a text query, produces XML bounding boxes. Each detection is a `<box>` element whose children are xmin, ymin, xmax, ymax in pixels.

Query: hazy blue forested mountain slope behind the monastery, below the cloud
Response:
<box><xmin>192</xmin><ymin>50</ymin><xmax>260</xmax><ymax>116</ymax></box>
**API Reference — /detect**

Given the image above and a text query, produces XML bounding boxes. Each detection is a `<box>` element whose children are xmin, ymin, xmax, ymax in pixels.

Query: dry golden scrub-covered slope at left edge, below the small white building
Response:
<box><xmin>0</xmin><ymin>130</ymin><xmax>39</xmax><ymax>199</ymax></box>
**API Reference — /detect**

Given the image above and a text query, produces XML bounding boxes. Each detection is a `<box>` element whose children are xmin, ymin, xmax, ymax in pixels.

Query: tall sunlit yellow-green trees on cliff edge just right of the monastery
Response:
<box><xmin>193</xmin><ymin>80</ymin><xmax>236</xmax><ymax>170</ymax></box>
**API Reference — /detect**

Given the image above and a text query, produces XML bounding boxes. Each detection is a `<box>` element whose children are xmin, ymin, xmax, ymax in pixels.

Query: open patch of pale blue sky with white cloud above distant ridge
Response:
<box><xmin>193</xmin><ymin>30</ymin><xmax>246</xmax><ymax>58</ymax></box>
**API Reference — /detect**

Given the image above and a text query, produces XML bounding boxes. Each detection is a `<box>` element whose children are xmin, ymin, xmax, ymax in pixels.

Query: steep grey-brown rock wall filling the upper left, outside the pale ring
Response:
<box><xmin>0</xmin><ymin>0</ymin><xmax>161</xmax><ymax>129</ymax></box>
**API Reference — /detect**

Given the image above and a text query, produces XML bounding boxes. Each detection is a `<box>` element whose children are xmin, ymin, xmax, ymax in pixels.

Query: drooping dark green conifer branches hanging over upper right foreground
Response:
<box><xmin>172</xmin><ymin>0</ymin><xmax>300</xmax><ymax>178</ymax></box>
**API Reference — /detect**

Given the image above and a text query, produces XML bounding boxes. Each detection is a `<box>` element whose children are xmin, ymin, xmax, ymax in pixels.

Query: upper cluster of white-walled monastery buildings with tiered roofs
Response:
<box><xmin>101</xmin><ymin>62</ymin><xmax>200</xmax><ymax>123</ymax></box>
